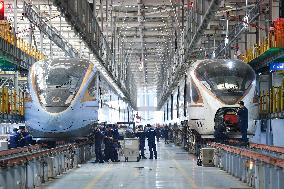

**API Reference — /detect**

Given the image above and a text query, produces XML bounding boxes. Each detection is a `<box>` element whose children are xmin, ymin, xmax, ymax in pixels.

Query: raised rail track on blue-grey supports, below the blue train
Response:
<box><xmin>0</xmin><ymin>141</ymin><xmax>94</xmax><ymax>189</ymax></box>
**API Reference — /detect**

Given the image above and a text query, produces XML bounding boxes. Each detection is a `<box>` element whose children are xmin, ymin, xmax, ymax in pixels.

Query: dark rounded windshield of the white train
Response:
<box><xmin>195</xmin><ymin>59</ymin><xmax>255</xmax><ymax>105</ymax></box>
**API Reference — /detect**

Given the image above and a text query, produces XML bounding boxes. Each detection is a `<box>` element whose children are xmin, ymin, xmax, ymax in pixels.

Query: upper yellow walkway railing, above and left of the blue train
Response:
<box><xmin>0</xmin><ymin>21</ymin><xmax>46</xmax><ymax>60</ymax></box>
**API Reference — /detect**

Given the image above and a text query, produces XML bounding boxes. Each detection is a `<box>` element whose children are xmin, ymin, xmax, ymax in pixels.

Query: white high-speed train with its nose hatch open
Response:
<box><xmin>164</xmin><ymin>59</ymin><xmax>258</xmax><ymax>141</ymax></box>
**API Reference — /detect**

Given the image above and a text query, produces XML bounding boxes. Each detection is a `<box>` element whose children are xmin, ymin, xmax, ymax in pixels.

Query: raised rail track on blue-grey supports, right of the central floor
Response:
<box><xmin>206</xmin><ymin>143</ymin><xmax>284</xmax><ymax>189</ymax></box>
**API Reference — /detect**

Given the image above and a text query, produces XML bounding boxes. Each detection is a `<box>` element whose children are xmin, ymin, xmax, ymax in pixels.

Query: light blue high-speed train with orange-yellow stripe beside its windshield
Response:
<box><xmin>25</xmin><ymin>58</ymin><xmax>132</xmax><ymax>140</ymax></box>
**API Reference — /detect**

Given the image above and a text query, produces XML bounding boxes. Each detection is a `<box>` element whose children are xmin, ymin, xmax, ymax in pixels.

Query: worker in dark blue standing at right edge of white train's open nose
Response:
<box><xmin>238</xmin><ymin>101</ymin><xmax>248</xmax><ymax>143</ymax></box>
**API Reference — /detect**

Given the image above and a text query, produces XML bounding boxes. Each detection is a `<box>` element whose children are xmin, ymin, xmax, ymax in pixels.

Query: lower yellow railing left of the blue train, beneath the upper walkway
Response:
<box><xmin>0</xmin><ymin>87</ymin><xmax>25</xmax><ymax>116</ymax></box>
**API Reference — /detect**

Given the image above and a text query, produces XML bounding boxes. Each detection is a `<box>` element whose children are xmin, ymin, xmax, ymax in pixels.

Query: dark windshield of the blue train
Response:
<box><xmin>34</xmin><ymin>59</ymin><xmax>89</xmax><ymax>113</ymax></box>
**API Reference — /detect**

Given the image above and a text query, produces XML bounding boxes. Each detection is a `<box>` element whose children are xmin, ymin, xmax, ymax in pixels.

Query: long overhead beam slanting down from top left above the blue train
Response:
<box><xmin>53</xmin><ymin>0</ymin><xmax>136</xmax><ymax>109</ymax></box>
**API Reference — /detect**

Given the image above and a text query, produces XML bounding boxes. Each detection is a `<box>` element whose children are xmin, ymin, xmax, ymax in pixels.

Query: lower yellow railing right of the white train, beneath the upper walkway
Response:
<box><xmin>259</xmin><ymin>79</ymin><xmax>284</xmax><ymax>114</ymax></box>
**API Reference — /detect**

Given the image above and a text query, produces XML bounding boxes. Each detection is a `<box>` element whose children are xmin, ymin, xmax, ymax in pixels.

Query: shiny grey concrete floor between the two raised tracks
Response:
<box><xmin>40</xmin><ymin>142</ymin><xmax>249</xmax><ymax>189</ymax></box>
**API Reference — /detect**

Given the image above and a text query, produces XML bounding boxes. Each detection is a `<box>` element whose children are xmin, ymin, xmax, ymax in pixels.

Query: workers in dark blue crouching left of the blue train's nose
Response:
<box><xmin>8</xmin><ymin>126</ymin><xmax>33</xmax><ymax>148</ymax></box>
